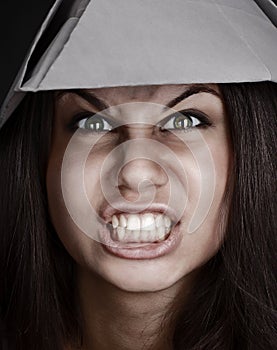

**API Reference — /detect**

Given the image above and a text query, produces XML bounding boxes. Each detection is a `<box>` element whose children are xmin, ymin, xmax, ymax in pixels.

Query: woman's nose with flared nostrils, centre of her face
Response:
<box><xmin>118</xmin><ymin>140</ymin><xmax>168</xmax><ymax>200</ymax></box>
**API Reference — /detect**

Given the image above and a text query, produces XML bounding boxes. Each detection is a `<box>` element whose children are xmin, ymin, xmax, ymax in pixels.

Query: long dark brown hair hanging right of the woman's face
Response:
<box><xmin>171</xmin><ymin>83</ymin><xmax>277</xmax><ymax>350</ymax></box>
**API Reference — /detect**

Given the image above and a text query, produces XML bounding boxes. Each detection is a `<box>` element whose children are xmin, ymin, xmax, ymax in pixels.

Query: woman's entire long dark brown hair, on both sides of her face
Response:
<box><xmin>0</xmin><ymin>82</ymin><xmax>277</xmax><ymax>350</ymax></box>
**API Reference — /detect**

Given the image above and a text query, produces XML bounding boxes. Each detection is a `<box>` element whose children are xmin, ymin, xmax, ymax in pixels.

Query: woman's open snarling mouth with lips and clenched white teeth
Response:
<box><xmin>98</xmin><ymin>211</ymin><xmax>182</xmax><ymax>260</ymax></box>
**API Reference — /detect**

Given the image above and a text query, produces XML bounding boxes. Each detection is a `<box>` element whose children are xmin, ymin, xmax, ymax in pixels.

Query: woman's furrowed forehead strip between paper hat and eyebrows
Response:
<box><xmin>74</xmin><ymin>84</ymin><xmax>219</xmax><ymax>105</ymax></box>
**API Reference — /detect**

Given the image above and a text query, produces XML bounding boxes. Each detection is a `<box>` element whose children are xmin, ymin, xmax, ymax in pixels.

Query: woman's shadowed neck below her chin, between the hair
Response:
<box><xmin>73</xmin><ymin>269</ymin><xmax>194</xmax><ymax>350</ymax></box>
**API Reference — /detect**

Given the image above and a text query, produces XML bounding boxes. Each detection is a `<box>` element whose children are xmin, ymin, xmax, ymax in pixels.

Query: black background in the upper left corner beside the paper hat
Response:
<box><xmin>0</xmin><ymin>0</ymin><xmax>277</xmax><ymax>104</ymax></box>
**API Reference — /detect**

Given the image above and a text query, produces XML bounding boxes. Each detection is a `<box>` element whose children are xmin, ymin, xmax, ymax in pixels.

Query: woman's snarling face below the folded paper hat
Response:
<box><xmin>47</xmin><ymin>85</ymin><xmax>231</xmax><ymax>291</ymax></box>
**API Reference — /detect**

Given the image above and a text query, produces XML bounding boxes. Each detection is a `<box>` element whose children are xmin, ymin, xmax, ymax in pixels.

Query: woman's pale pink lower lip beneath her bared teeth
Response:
<box><xmin>98</xmin><ymin>223</ymin><xmax>182</xmax><ymax>260</ymax></box>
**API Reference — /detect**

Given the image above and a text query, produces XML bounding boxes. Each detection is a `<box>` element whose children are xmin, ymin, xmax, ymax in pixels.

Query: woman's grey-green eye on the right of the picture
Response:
<box><xmin>161</xmin><ymin>112</ymin><xmax>210</xmax><ymax>130</ymax></box>
